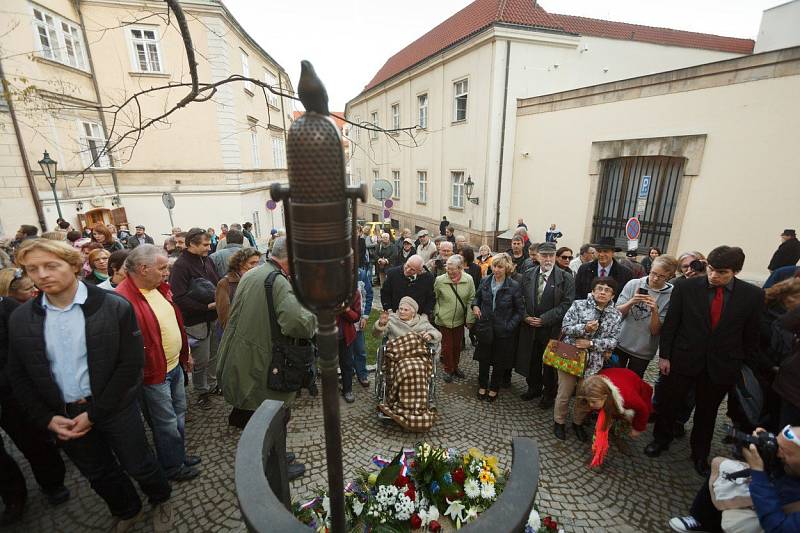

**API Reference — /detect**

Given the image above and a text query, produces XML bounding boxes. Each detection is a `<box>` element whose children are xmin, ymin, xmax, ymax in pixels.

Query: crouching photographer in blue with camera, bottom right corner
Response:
<box><xmin>669</xmin><ymin>426</ymin><xmax>800</xmax><ymax>533</ymax></box>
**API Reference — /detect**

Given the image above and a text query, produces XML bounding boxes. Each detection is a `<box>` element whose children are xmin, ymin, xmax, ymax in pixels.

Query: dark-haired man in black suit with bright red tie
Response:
<box><xmin>645</xmin><ymin>246</ymin><xmax>764</xmax><ymax>475</ymax></box>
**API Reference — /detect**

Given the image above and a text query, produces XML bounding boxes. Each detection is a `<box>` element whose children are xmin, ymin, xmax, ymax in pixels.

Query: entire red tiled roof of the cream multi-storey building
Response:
<box><xmin>364</xmin><ymin>0</ymin><xmax>754</xmax><ymax>91</ymax></box>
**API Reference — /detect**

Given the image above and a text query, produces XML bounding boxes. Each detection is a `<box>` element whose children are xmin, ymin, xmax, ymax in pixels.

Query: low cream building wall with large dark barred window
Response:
<box><xmin>511</xmin><ymin>47</ymin><xmax>800</xmax><ymax>280</ymax></box>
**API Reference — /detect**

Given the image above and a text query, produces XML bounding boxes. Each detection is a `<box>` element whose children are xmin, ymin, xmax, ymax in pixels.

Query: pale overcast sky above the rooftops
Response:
<box><xmin>223</xmin><ymin>0</ymin><xmax>786</xmax><ymax>111</ymax></box>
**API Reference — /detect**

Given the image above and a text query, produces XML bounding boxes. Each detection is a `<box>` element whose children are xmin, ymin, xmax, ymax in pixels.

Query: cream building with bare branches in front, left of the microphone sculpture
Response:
<box><xmin>0</xmin><ymin>0</ymin><xmax>293</xmax><ymax>236</ymax></box>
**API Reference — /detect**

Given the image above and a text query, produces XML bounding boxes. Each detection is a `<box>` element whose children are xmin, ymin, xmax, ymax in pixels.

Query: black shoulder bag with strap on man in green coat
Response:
<box><xmin>264</xmin><ymin>270</ymin><xmax>316</xmax><ymax>392</ymax></box>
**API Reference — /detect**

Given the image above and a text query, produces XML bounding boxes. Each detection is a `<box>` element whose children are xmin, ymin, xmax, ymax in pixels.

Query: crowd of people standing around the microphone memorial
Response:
<box><xmin>0</xmin><ymin>214</ymin><xmax>800</xmax><ymax>531</ymax></box>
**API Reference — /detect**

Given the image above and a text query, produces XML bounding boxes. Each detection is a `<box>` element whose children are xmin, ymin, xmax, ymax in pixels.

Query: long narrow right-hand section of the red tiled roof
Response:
<box><xmin>550</xmin><ymin>14</ymin><xmax>755</xmax><ymax>54</ymax></box>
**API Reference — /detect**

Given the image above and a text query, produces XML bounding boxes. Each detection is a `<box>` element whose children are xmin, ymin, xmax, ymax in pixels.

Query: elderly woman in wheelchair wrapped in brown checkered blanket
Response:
<box><xmin>373</xmin><ymin>296</ymin><xmax>442</xmax><ymax>432</ymax></box>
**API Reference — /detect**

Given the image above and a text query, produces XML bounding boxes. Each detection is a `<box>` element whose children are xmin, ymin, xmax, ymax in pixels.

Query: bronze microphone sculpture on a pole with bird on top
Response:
<box><xmin>270</xmin><ymin>61</ymin><xmax>366</xmax><ymax>532</ymax></box>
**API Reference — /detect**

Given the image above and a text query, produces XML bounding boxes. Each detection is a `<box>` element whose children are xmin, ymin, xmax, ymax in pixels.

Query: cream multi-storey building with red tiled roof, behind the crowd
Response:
<box><xmin>346</xmin><ymin>0</ymin><xmax>753</xmax><ymax>243</ymax></box>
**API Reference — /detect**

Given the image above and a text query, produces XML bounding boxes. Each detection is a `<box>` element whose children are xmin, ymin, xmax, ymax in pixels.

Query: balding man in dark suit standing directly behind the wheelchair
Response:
<box><xmin>381</xmin><ymin>255</ymin><xmax>434</xmax><ymax>318</ymax></box>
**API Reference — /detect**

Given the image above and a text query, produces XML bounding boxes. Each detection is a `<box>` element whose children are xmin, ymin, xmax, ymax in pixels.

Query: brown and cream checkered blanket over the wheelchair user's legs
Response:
<box><xmin>378</xmin><ymin>333</ymin><xmax>436</xmax><ymax>432</ymax></box>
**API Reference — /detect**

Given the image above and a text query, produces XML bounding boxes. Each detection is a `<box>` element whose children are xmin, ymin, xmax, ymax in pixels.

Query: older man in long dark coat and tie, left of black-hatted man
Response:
<box><xmin>515</xmin><ymin>242</ymin><xmax>575</xmax><ymax>409</ymax></box>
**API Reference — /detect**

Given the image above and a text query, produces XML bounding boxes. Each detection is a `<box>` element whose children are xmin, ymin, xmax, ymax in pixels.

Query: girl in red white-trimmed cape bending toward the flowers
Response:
<box><xmin>577</xmin><ymin>368</ymin><xmax>653</xmax><ymax>467</ymax></box>
